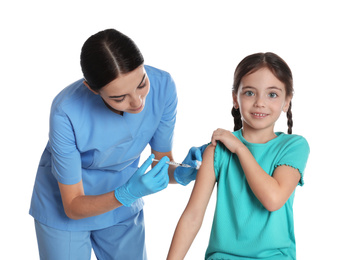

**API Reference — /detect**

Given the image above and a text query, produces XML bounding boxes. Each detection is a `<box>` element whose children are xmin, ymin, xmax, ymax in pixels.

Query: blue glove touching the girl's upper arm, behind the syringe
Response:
<box><xmin>174</xmin><ymin>144</ymin><xmax>208</xmax><ymax>186</ymax></box>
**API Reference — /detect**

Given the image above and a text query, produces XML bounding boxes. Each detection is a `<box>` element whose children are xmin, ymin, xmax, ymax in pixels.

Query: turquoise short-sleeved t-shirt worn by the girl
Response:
<box><xmin>205</xmin><ymin>130</ymin><xmax>310</xmax><ymax>260</ymax></box>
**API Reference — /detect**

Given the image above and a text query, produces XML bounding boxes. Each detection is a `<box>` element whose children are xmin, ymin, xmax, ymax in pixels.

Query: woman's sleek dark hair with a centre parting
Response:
<box><xmin>81</xmin><ymin>29</ymin><xmax>144</xmax><ymax>91</ymax></box>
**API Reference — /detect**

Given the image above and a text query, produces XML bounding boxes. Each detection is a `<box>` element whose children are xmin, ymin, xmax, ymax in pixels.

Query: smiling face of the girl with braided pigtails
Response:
<box><xmin>233</xmin><ymin>68</ymin><xmax>292</xmax><ymax>134</ymax></box>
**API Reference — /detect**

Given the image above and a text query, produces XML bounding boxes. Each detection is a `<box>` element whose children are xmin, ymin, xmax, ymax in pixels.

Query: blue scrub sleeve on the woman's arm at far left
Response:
<box><xmin>49</xmin><ymin>105</ymin><xmax>82</xmax><ymax>184</ymax></box>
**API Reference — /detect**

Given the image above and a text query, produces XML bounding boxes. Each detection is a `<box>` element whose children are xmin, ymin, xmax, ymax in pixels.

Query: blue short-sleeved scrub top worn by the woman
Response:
<box><xmin>29</xmin><ymin>66</ymin><xmax>178</xmax><ymax>231</ymax></box>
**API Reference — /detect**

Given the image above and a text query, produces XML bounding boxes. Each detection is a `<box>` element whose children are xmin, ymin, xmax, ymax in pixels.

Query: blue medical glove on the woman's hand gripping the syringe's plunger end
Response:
<box><xmin>115</xmin><ymin>154</ymin><xmax>169</xmax><ymax>207</ymax></box>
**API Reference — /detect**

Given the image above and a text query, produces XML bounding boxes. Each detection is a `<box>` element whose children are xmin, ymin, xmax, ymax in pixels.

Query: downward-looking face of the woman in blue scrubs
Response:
<box><xmin>85</xmin><ymin>65</ymin><xmax>150</xmax><ymax>115</ymax></box>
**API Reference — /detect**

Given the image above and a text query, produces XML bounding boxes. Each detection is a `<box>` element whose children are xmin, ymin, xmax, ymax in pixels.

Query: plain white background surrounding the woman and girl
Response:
<box><xmin>0</xmin><ymin>0</ymin><xmax>342</xmax><ymax>260</ymax></box>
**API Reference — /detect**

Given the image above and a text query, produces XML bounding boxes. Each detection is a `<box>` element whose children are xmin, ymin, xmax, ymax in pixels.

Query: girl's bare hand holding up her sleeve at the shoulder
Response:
<box><xmin>211</xmin><ymin>128</ymin><xmax>244</xmax><ymax>153</ymax></box>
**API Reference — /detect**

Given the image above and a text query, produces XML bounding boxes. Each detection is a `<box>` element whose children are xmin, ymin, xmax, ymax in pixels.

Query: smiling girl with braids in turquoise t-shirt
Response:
<box><xmin>167</xmin><ymin>53</ymin><xmax>309</xmax><ymax>260</ymax></box>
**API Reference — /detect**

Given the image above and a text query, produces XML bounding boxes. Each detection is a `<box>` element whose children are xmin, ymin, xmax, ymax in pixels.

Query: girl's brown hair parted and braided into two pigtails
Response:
<box><xmin>232</xmin><ymin>52</ymin><xmax>293</xmax><ymax>134</ymax></box>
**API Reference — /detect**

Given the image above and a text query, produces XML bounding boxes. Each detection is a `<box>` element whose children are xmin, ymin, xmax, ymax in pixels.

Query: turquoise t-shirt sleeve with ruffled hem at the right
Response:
<box><xmin>275</xmin><ymin>136</ymin><xmax>310</xmax><ymax>186</ymax></box>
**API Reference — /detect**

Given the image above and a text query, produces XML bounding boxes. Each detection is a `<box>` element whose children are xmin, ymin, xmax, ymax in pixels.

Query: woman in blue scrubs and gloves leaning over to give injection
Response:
<box><xmin>30</xmin><ymin>29</ymin><xmax>203</xmax><ymax>260</ymax></box>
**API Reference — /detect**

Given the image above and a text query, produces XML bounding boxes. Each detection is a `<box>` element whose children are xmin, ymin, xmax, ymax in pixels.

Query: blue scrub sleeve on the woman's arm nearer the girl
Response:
<box><xmin>150</xmin><ymin>75</ymin><xmax>178</xmax><ymax>152</ymax></box>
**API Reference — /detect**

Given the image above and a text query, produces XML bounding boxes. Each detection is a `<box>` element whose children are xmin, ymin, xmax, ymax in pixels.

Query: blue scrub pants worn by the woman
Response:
<box><xmin>35</xmin><ymin>210</ymin><xmax>147</xmax><ymax>260</ymax></box>
